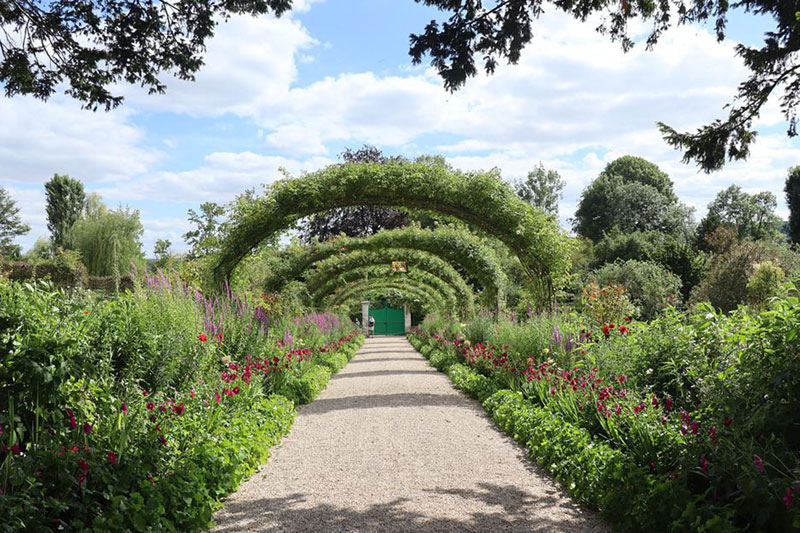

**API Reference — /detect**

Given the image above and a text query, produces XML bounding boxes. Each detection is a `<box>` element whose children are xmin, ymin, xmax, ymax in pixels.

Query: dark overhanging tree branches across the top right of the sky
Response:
<box><xmin>409</xmin><ymin>0</ymin><xmax>800</xmax><ymax>172</ymax></box>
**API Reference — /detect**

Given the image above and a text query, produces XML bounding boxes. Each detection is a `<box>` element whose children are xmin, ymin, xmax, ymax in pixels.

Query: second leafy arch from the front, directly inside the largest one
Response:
<box><xmin>265</xmin><ymin>226</ymin><xmax>508</xmax><ymax>305</ymax></box>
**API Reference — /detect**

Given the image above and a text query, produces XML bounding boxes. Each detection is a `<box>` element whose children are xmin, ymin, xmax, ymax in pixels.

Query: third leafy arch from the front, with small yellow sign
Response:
<box><xmin>306</xmin><ymin>248</ymin><xmax>475</xmax><ymax>311</ymax></box>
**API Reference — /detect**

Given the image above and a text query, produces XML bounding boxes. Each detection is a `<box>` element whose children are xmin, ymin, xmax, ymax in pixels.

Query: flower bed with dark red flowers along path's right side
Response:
<box><xmin>410</xmin><ymin>288</ymin><xmax>800</xmax><ymax>531</ymax></box>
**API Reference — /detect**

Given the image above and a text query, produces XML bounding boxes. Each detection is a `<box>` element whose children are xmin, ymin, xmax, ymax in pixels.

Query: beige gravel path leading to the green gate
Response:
<box><xmin>214</xmin><ymin>337</ymin><xmax>610</xmax><ymax>533</ymax></box>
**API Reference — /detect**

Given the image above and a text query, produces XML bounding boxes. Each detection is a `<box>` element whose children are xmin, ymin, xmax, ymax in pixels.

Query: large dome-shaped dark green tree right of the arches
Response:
<box><xmin>573</xmin><ymin>156</ymin><xmax>692</xmax><ymax>242</ymax></box>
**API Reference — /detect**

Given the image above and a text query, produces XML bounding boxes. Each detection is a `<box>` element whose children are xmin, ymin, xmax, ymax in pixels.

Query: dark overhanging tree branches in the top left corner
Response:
<box><xmin>0</xmin><ymin>0</ymin><xmax>292</xmax><ymax>110</ymax></box>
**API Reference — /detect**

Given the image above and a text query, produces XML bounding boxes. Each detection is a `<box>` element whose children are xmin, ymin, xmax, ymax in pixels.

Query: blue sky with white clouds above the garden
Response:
<box><xmin>0</xmin><ymin>0</ymin><xmax>800</xmax><ymax>256</ymax></box>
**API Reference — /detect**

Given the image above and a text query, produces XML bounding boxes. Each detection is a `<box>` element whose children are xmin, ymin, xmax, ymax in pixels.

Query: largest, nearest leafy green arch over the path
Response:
<box><xmin>214</xmin><ymin>162</ymin><xmax>569</xmax><ymax>299</ymax></box>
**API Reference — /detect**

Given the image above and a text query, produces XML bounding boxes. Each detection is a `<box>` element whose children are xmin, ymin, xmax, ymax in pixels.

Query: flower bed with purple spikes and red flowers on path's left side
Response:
<box><xmin>0</xmin><ymin>280</ymin><xmax>363</xmax><ymax>531</ymax></box>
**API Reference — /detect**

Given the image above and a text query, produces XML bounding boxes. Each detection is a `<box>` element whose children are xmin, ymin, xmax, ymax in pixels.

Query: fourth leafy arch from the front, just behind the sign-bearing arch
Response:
<box><xmin>309</xmin><ymin>265</ymin><xmax>466</xmax><ymax>316</ymax></box>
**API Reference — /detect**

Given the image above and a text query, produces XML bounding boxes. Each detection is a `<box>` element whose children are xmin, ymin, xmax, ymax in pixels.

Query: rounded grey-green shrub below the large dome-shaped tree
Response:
<box><xmin>590</xmin><ymin>259</ymin><xmax>681</xmax><ymax>323</ymax></box>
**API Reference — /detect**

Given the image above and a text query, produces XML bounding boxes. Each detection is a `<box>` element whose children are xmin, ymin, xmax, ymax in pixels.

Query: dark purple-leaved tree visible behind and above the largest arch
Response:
<box><xmin>300</xmin><ymin>144</ymin><xmax>412</xmax><ymax>243</ymax></box>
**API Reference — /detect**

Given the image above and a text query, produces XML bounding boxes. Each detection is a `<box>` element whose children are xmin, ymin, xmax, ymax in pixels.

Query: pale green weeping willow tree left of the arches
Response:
<box><xmin>70</xmin><ymin>197</ymin><xmax>144</xmax><ymax>279</ymax></box>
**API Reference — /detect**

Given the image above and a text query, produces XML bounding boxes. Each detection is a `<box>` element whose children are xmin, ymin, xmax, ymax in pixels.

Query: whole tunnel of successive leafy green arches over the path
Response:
<box><xmin>213</xmin><ymin>162</ymin><xmax>569</xmax><ymax>316</ymax></box>
